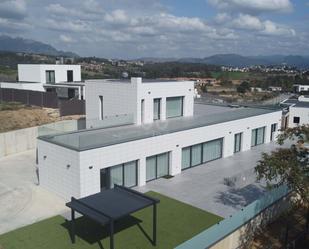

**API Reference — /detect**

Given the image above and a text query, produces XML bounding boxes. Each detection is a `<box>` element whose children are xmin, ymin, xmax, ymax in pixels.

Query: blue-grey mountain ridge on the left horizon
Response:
<box><xmin>0</xmin><ymin>35</ymin><xmax>78</xmax><ymax>57</ymax></box>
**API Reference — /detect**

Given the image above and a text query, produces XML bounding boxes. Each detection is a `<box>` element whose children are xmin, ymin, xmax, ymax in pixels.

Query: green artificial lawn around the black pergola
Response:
<box><xmin>0</xmin><ymin>192</ymin><xmax>222</xmax><ymax>249</ymax></box>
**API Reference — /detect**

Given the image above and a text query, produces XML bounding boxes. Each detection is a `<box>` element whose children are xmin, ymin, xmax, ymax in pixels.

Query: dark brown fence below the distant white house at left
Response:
<box><xmin>0</xmin><ymin>88</ymin><xmax>85</xmax><ymax>116</ymax></box>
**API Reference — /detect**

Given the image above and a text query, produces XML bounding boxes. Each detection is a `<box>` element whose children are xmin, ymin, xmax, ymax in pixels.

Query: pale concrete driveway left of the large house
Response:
<box><xmin>0</xmin><ymin>150</ymin><xmax>65</xmax><ymax>234</ymax></box>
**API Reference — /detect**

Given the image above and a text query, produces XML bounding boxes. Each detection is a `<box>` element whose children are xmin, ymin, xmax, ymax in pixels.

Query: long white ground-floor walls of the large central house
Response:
<box><xmin>39</xmin><ymin>111</ymin><xmax>281</xmax><ymax>198</ymax></box>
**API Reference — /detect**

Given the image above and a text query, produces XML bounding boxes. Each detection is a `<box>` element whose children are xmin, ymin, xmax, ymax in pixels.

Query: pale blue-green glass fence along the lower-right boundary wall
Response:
<box><xmin>175</xmin><ymin>186</ymin><xmax>290</xmax><ymax>249</ymax></box>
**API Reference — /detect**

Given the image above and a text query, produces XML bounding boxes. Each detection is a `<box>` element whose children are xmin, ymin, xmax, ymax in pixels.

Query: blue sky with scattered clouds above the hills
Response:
<box><xmin>0</xmin><ymin>0</ymin><xmax>309</xmax><ymax>58</ymax></box>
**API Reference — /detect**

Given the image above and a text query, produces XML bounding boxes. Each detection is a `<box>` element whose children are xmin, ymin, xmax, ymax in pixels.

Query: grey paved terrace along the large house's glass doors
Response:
<box><xmin>136</xmin><ymin>143</ymin><xmax>284</xmax><ymax>217</ymax></box>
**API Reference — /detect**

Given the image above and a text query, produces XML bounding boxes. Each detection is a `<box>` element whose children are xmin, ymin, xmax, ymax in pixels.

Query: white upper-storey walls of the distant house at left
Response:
<box><xmin>18</xmin><ymin>64</ymin><xmax>81</xmax><ymax>84</ymax></box>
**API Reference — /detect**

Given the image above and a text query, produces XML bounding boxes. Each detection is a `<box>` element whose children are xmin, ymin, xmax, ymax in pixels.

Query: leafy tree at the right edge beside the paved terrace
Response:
<box><xmin>255</xmin><ymin>125</ymin><xmax>309</xmax><ymax>208</ymax></box>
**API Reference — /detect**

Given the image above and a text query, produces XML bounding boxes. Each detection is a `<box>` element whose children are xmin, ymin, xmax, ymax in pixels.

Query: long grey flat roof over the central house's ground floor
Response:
<box><xmin>39</xmin><ymin>105</ymin><xmax>281</xmax><ymax>151</ymax></box>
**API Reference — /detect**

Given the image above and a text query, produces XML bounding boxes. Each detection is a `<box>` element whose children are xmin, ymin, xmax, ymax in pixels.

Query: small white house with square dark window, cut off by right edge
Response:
<box><xmin>281</xmin><ymin>95</ymin><xmax>309</xmax><ymax>128</ymax></box>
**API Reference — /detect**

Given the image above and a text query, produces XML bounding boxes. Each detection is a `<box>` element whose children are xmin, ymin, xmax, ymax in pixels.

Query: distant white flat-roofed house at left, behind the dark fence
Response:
<box><xmin>0</xmin><ymin>64</ymin><xmax>84</xmax><ymax>99</ymax></box>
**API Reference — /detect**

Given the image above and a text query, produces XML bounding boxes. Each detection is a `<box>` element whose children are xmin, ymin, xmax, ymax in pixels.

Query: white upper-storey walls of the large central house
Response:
<box><xmin>85</xmin><ymin>78</ymin><xmax>194</xmax><ymax>127</ymax></box>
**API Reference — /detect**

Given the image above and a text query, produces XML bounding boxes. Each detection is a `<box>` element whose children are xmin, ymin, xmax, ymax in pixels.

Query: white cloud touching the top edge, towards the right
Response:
<box><xmin>208</xmin><ymin>0</ymin><xmax>293</xmax><ymax>13</ymax></box>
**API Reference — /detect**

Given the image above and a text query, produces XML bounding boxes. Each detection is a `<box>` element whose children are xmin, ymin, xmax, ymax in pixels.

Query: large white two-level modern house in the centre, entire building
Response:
<box><xmin>38</xmin><ymin>78</ymin><xmax>282</xmax><ymax>199</ymax></box>
